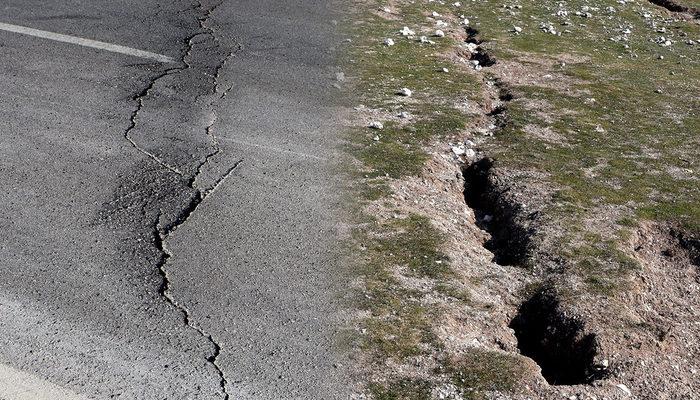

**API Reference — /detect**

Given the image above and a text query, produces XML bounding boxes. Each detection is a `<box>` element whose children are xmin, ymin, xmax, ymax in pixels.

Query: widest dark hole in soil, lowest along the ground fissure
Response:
<box><xmin>510</xmin><ymin>290</ymin><xmax>606</xmax><ymax>385</ymax></box>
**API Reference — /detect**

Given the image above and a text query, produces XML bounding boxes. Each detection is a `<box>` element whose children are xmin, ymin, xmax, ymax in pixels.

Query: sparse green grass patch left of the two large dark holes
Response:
<box><xmin>357</xmin><ymin>215</ymin><xmax>451</xmax><ymax>361</ymax></box>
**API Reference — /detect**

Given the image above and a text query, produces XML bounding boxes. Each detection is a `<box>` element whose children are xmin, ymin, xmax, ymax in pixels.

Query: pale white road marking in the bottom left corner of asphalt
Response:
<box><xmin>0</xmin><ymin>364</ymin><xmax>89</xmax><ymax>400</ymax></box>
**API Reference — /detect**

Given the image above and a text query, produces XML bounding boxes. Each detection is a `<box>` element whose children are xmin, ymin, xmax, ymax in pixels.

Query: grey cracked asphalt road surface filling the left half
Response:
<box><xmin>0</xmin><ymin>0</ymin><xmax>348</xmax><ymax>400</ymax></box>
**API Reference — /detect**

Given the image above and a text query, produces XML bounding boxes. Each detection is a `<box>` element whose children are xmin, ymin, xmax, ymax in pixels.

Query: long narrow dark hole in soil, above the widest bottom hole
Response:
<box><xmin>462</xmin><ymin>158</ymin><xmax>529</xmax><ymax>265</ymax></box>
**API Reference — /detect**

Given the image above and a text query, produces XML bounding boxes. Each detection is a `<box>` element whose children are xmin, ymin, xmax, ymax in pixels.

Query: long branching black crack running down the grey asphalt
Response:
<box><xmin>124</xmin><ymin>0</ymin><xmax>243</xmax><ymax>400</ymax></box>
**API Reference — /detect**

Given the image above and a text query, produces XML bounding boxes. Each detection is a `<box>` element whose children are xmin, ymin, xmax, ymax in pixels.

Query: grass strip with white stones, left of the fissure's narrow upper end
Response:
<box><xmin>346</xmin><ymin>2</ymin><xmax>480</xmax><ymax>179</ymax></box>
